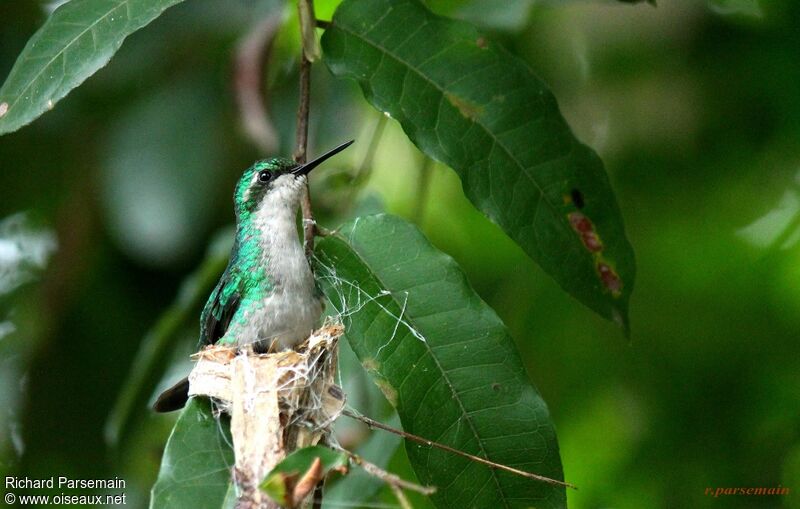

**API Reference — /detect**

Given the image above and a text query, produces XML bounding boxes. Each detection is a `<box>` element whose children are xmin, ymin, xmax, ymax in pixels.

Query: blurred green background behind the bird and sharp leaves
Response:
<box><xmin>0</xmin><ymin>0</ymin><xmax>800</xmax><ymax>508</ymax></box>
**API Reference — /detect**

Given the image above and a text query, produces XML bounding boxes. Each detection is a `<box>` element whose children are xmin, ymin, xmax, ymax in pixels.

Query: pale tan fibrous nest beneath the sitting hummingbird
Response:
<box><xmin>189</xmin><ymin>322</ymin><xmax>345</xmax><ymax>508</ymax></box>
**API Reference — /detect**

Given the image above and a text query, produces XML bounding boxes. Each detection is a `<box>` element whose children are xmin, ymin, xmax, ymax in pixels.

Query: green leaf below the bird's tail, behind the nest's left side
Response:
<box><xmin>150</xmin><ymin>397</ymin><xmax>233</xmax><ymax>509</ymax></box>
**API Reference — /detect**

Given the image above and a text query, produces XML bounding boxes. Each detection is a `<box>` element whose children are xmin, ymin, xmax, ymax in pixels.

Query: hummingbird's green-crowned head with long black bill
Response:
<box><xmin>233</xmin><ymin>140</ymin><xmax>353</xmax><ymax>217</ymax></box>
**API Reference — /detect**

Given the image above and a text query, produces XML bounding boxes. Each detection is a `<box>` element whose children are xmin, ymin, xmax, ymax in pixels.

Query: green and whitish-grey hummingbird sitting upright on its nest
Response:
<box><xmin>153</xmin><ymin>140</ymin><xmax>353</xmax><ymax>412</ymax></box>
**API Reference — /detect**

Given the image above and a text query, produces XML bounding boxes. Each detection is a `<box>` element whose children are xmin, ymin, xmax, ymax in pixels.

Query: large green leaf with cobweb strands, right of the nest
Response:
<box><xmin>316</xmin><ymin>215</ymin><xmax>565</xmax><ymax>509</ymax></box>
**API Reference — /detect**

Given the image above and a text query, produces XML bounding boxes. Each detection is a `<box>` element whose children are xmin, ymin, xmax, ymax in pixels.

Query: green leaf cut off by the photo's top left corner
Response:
<box><xmin>0</xmin><ymin>0</ymin><xmax>182</xmax><ymax>134</ymax></box>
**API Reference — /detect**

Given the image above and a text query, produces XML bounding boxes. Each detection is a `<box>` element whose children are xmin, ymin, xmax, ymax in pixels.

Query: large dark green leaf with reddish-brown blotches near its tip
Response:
<box><xmin>322</xmin><ymin>0</ymin><xmax>635</xmax><ymax>327</ymax></box>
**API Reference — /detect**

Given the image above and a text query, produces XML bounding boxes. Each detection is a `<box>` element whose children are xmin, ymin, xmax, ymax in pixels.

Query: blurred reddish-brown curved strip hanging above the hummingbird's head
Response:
<box><xmin>234</xmin><ymin>15</ymin><xmax>281</xmax><ymax>154</ymax></box>
